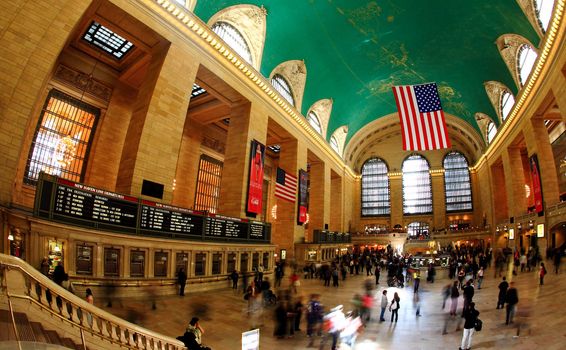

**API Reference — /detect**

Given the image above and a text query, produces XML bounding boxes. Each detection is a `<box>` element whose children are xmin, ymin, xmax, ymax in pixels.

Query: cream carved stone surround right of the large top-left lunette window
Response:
<box><xmin>208</xmin><ymin>4</ymin><xmax>267</xmax><ymax>71</ymax></box>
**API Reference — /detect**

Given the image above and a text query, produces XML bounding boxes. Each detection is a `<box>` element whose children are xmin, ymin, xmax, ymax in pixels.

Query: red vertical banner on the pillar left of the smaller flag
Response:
<box><xmin>246</xmin><ymin>140</ymin><xmax>265</xmax><ymax>217</ymax></box>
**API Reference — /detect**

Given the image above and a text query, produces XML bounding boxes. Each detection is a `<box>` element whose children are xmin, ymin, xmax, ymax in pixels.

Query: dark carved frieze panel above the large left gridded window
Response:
<box><xmin>54</xmin><ymin>64</ymin><xmax>112</xmax><ymax>102</ymax></box>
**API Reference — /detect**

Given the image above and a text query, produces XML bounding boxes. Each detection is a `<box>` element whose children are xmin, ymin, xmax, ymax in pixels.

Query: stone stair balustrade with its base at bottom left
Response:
<box><xmin>0</xmin><ymin>254</ymin><xmax>186</xmax><ymax>350</ymax></box>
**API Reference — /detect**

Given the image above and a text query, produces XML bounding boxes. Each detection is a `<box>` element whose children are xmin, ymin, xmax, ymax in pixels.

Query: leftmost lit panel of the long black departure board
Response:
<box><xmin>53</xmin><ymin>179</ymin><xmax>138</xmax><ymax>228</ymax></box>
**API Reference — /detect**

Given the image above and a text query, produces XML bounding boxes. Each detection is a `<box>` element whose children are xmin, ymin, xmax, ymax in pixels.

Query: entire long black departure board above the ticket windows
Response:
<box><xmin>34</xmin><ymin>174</ymin><xmax>271</xmax><ymax>243</ymax></box>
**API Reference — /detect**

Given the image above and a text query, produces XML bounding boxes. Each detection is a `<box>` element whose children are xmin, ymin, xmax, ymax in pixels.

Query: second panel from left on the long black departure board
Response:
<box><xmin>140</xmin><ymin>200</ymin><xmax>204</xmax><ymax>236</ymax></box>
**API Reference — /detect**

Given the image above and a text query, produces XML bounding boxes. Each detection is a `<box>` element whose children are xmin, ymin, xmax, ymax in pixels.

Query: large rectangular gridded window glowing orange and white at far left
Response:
<box><xmin>24</xmin><ymin>90</ymin><xmax>100</xmax><ymax>186</ymax></box>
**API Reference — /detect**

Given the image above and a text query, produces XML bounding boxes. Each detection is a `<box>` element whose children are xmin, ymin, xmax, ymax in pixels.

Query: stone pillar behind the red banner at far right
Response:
<box><xmin>523</xmin><ymin>119</ymin><xmax>566</xmax><ymax>206</ymax></box>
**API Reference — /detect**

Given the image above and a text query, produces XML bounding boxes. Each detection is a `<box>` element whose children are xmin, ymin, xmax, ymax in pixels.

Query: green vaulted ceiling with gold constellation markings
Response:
<box><xmin>195</xmin><ymin>0</ymin><xmax>539</xmax><ymax>142</ymax></box>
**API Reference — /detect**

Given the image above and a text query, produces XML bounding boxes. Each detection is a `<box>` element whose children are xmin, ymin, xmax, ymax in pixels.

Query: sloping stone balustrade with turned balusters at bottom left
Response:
<box><xmin>0</xmin><ymin>254</ymin><xmax>186</xmax><ymax>350</ymax></box>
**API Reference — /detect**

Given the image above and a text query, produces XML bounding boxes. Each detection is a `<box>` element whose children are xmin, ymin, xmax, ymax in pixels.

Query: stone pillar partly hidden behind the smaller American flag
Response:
<box><xmin>272</xmin><ymin>139</ymin><xmax>307</xmax><ymax>259</ymax></box>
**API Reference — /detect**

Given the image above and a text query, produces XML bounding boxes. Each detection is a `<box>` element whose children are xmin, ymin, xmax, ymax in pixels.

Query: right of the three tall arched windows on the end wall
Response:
<box><xmin>443</xmin><ymin>152</ymin><xmax>472</xmax><ymax>212</ymax></box>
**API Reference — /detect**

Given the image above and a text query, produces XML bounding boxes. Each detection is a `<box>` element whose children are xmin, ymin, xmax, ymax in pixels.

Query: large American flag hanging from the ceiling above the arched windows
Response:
<box><xmin>393</xmin><ymin>83</ymin><xmax>451</xmax><ymax>151</ymax></box>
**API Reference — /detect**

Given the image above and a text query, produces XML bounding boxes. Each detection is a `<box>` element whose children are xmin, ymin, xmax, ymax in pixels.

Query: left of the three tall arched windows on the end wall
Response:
<box><xmin>362</xmin><ymin>158</ymin><xmax>391</xmax><ymax>216</ymax></box>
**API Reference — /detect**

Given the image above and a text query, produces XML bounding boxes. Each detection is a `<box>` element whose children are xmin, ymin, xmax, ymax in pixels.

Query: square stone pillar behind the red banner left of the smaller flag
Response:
<box><xmin>218</xmin><ymin>103</ymin><xmax>268</xmax><ymax>217</ymax></box>
